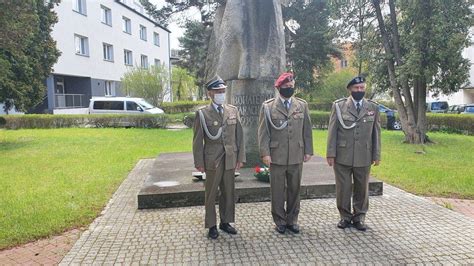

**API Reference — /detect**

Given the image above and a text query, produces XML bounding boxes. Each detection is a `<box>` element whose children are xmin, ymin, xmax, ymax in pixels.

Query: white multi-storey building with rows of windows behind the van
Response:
<box><xmin>36</xmin><ymin>0</ymin><xmax>170</xmax><ymax>112</ymax></box>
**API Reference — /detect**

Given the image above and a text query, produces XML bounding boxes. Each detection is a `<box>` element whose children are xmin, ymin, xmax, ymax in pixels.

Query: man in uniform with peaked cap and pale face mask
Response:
<box><xmin>193</xmin><ymin>76</ymin><xmax>245</xmax><ymax>239</ymax></box>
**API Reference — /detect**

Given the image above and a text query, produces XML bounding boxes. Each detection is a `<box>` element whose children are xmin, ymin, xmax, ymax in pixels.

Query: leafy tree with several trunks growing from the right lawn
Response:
<box><xmin>372</xmin><ymin>0</ymin><xmax>472</xmax><ymax>143</ymax></box>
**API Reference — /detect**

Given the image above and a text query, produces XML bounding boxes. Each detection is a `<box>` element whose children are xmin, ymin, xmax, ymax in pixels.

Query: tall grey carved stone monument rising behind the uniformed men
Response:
<box><xmin>206</xmin><ymin>0</ymin><xmax>285</xmax><ymax>167</ymax></box>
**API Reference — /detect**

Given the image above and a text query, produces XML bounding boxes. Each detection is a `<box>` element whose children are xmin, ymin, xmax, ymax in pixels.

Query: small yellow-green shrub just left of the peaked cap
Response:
<box><xmin>171</xmin><ymin>67</ymin><xmax>197</xmax><ymax>101</ymax></box>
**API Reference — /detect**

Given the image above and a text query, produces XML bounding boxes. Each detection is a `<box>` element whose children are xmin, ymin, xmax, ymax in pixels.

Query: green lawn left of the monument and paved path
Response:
<box><xmin>0</xmin><ymin>129</ymin><xmax>192</xmax><ymax>249</ymax></box>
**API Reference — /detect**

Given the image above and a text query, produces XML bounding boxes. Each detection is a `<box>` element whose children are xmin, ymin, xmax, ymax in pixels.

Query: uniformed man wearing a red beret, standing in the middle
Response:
<box><xmin>258</xmin><ymin>73</ymin><xmax>313</xmax><ymax>234</ymax></box>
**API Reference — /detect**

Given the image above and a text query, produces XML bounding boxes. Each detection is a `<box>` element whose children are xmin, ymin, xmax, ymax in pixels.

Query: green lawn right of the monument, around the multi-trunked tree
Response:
<box><xmin>313</xmin><ymin>130</ymin><xmax>474</xmax><ymax>199</ymax></box>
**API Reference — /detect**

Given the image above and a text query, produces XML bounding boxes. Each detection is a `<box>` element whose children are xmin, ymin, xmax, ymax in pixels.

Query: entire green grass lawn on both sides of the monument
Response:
<box><xmin>0</xmin><ymin>128</ymin><xmax>474</xmax><ymax>249</ymax></box>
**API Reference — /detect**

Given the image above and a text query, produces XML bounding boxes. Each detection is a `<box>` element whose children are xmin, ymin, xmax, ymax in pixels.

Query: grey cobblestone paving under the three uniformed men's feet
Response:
<box><xmin>61</xmin><ymin>160</ymin><xmax>474</xmax><ymax>264</ymax></box>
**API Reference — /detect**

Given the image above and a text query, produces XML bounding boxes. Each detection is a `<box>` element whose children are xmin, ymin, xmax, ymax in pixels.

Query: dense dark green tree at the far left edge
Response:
<box><xmin>0</xmin><ymin>0</ymin><xmax>60</xmax><ymax>113</ymax></box>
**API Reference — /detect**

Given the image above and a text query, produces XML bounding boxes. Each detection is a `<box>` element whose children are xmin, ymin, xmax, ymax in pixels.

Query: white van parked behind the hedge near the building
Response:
<box><xmin>89</xmin><ymin>97</ymin><xmax>164</xmax><ymax>114</ymax></box>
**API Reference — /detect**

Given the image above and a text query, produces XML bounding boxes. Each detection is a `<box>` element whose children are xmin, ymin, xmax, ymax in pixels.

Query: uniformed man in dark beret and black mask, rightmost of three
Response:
<box><xmin>326</xmin><ymin>77</ymin><xmax>380</xmax><ymax>231</ymax></box>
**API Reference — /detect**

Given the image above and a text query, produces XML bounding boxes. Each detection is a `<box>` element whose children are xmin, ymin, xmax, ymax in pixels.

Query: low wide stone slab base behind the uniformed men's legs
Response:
<box><xmin>138</xmin><ymin>153</ymin><xmax>383</xmax><ymax>209</ymax></box>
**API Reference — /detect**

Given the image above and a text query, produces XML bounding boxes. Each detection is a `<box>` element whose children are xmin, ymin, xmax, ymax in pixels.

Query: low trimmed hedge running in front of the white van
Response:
<box><xmin>0</xmin><ymin>114</ymin><xmax>170</xmax><ymax>129</ymax></box>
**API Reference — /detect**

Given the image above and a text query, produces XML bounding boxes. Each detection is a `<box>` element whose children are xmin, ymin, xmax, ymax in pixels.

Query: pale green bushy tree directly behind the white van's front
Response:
<box><xmin>121</xmin><ymin>65</ymin><xmax>170</xmax><ymax>106</ymax></box>
